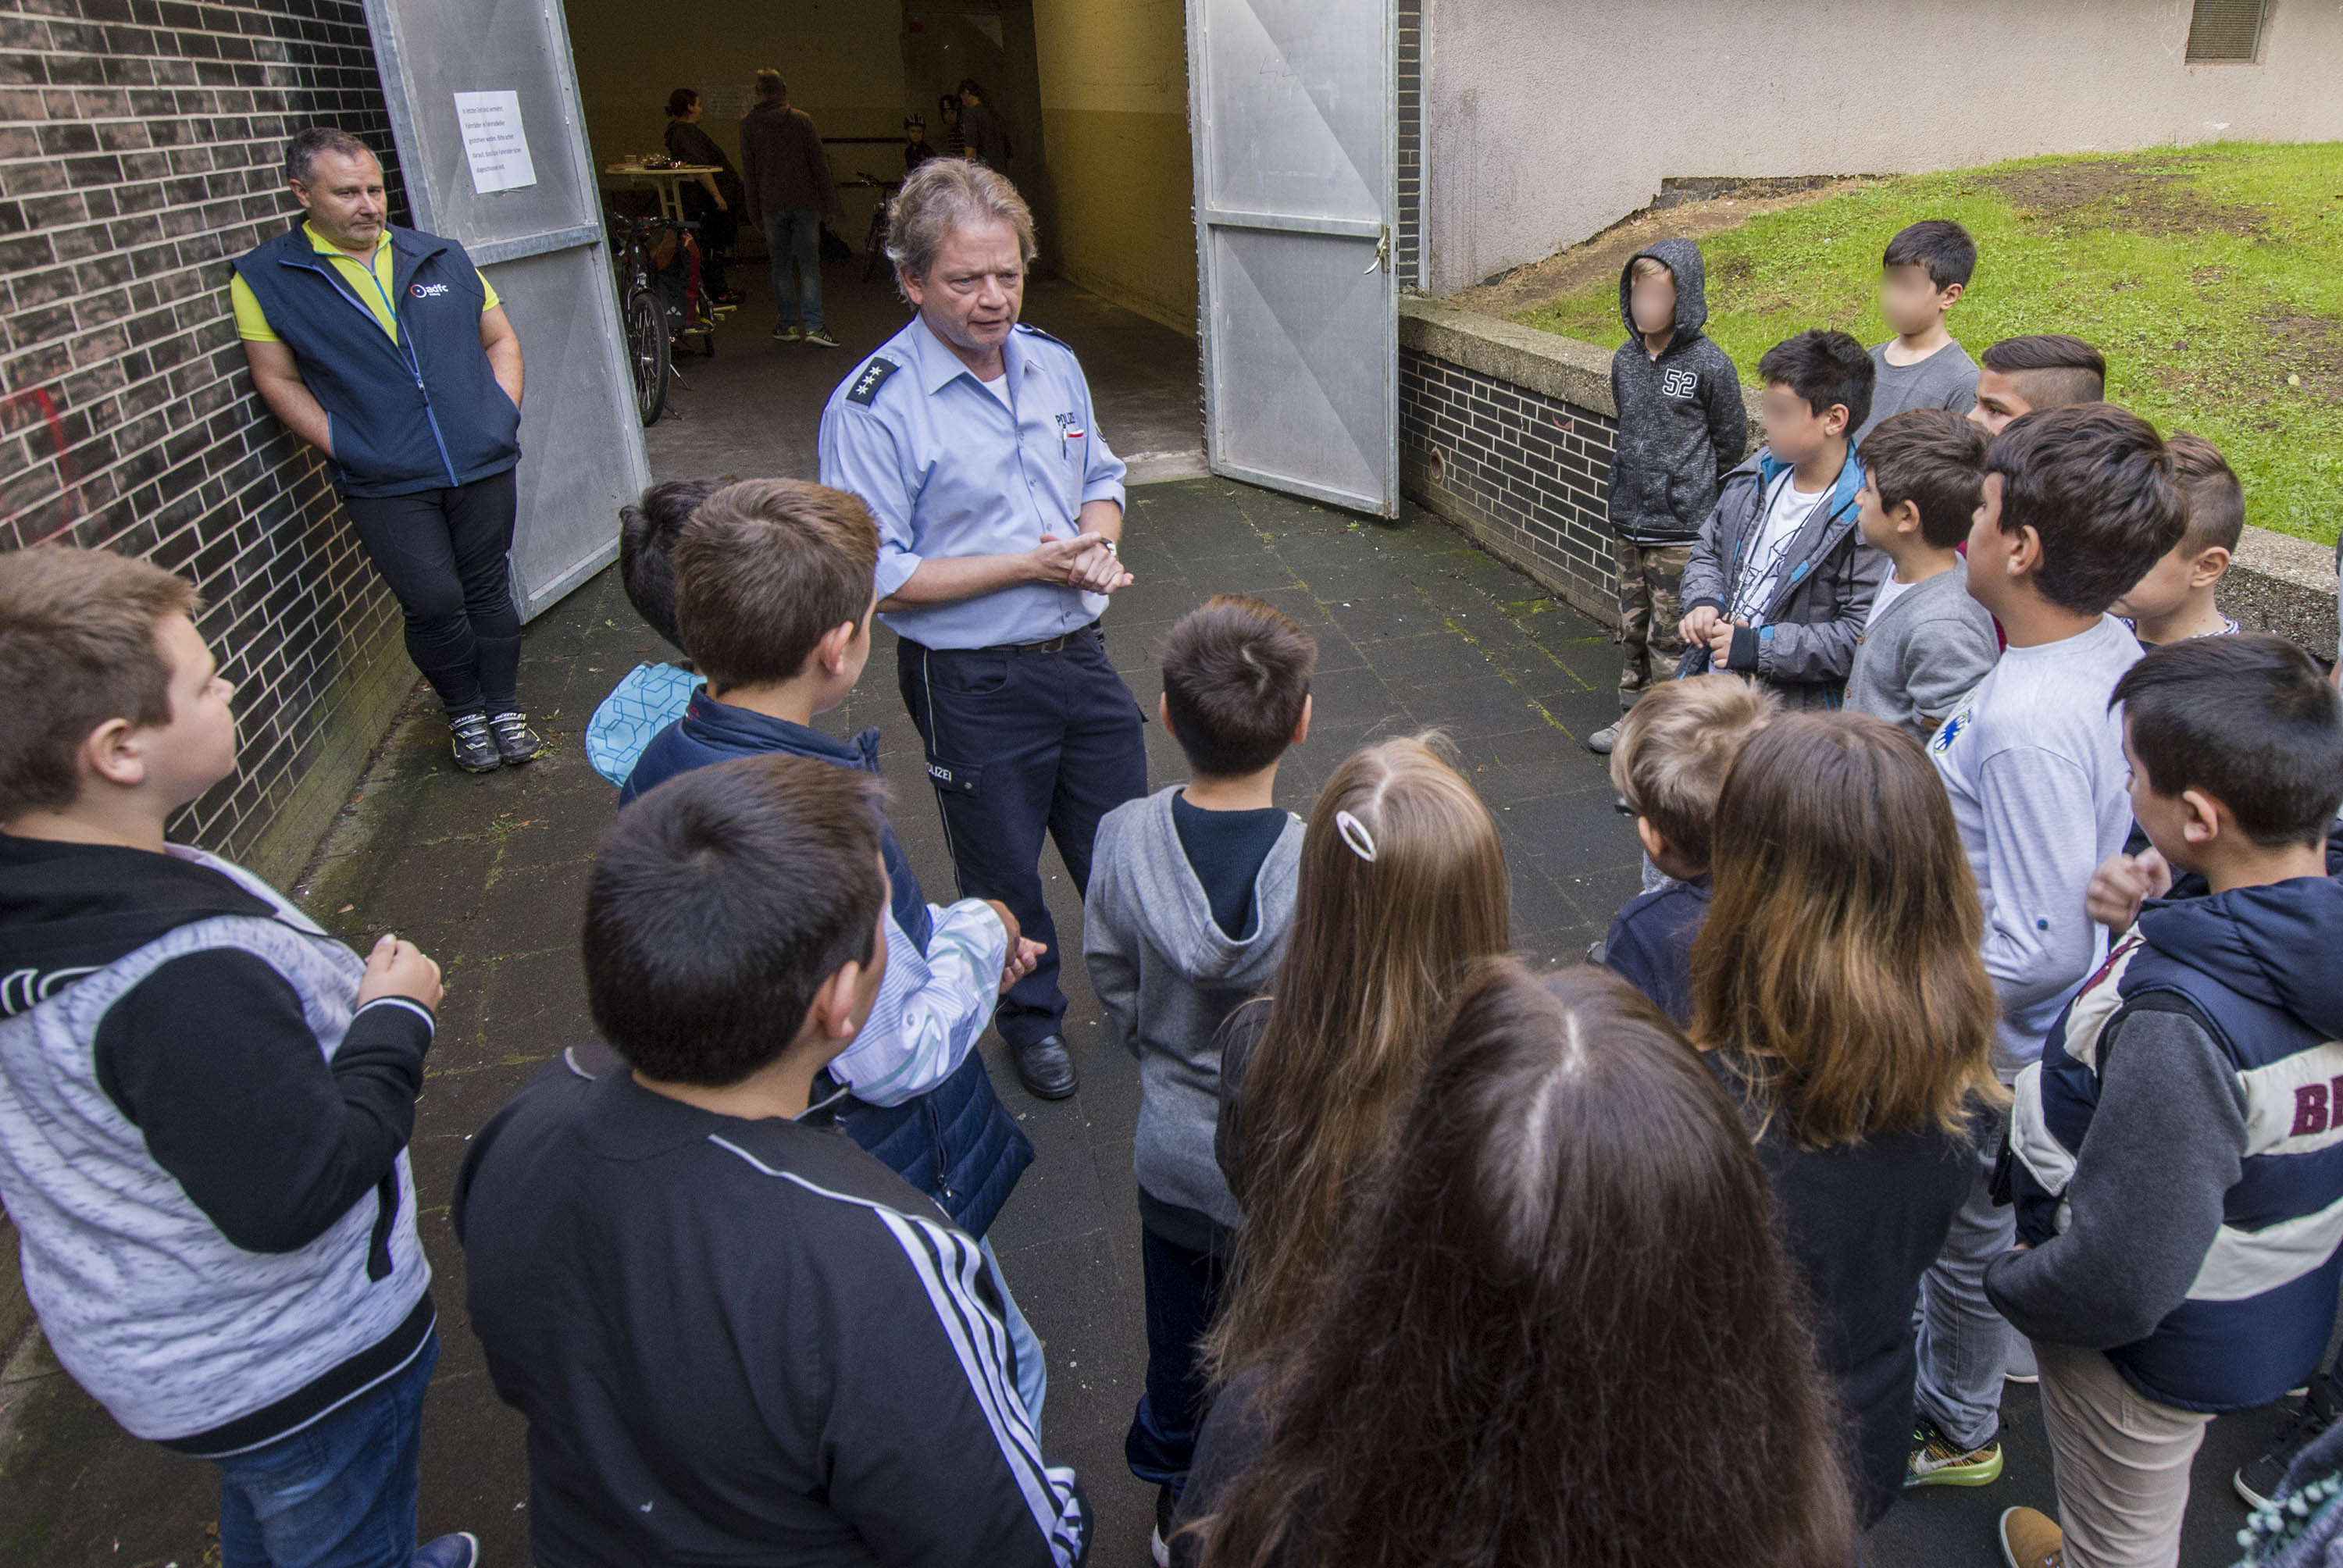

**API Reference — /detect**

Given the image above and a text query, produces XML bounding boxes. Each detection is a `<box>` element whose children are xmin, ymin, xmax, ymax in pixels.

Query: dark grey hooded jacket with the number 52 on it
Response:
<box><xmin>1610</xmin><ymin>239</ymin><xmax>1750</xmax><ymax>543</ymax></box>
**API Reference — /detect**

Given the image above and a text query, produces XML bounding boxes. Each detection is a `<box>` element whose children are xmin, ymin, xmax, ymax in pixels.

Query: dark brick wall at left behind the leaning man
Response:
<box><xmin>0</xmin><ymin>0</ymin><xmax>415</xmax><ymax>879</ymax></box>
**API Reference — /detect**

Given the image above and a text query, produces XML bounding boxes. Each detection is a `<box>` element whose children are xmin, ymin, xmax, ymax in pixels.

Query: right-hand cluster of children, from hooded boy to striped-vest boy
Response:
<box><xmin>1591</xmin><ymin>220</ymin><xmax>2343</xmax><ymax>1568</ymax></box>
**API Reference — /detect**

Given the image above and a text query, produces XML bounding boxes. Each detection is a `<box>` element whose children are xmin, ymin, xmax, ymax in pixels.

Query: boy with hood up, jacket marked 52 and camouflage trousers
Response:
<box><xmin>1586</xmin><ymin>239</ymin><xmax>1750</xmax><ymax>752</ymax></box>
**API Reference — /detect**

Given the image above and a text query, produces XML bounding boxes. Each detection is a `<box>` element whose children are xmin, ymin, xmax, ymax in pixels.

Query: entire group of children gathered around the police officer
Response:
<box><xmin>0</xmin><ymin>207</ymin><xmax>2343</xmax><ymax>1568</ymax></box>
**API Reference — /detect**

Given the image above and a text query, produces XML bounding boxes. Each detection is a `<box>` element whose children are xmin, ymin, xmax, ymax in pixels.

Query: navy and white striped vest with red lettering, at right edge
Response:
<box><xmin>2010</xmin><ymin>923</ymin><xmax>2343</xmax><ymax>1413</ymax></box>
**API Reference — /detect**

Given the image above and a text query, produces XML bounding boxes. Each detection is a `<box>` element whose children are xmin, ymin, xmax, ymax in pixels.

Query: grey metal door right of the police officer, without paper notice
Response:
<box><xmin>1188</xmin><ymin>0</ymin><xmax>1399</xmax><ymax>518</ymax></box>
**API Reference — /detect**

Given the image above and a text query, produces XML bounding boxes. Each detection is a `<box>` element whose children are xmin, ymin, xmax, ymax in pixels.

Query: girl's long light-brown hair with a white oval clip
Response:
<box><xmin>1204</xmin><ymin>736</ymin><xmax>1509</xmax><ymax>1376</ymax></box>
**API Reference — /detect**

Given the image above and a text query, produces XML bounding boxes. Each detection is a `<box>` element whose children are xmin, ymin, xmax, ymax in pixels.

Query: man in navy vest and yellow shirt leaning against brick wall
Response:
<box><xmin>230</xmin><ymin>127</ymin><xmax>544</xmax><ymax>773</ymax></box>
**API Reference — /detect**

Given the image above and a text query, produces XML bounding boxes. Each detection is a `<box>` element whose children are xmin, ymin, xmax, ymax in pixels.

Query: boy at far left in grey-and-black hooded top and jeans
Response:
<box><xmin>0</xmin><ymin>546</ymin><xmax>478</xmax><ymax>1568</ymax></box>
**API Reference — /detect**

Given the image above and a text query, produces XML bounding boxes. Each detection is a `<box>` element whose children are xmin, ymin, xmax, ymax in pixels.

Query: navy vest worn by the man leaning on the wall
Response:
<box><xmin>234</xmin><ymin>225</ymin><xmax>520</xmax><ymax>497</ymax></box>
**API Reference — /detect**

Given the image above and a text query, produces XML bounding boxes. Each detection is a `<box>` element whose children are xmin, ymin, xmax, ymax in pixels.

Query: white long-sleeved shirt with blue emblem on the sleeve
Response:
<box><xmin>1928</xmin><ymin>614</ymin><xmax>2139</xmax><ymax>1083</ymax></box>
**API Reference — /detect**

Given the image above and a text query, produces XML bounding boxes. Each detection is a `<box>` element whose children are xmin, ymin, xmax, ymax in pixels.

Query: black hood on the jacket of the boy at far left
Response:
<box><xmin>0</xmin><ymin>835</ymin><xmax>276</xmax><ymax>1017</ymax></box>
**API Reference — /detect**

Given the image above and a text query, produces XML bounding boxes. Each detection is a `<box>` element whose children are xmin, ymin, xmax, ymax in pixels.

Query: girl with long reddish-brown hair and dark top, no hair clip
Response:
<box><xmin>1692</xmin><ymin>712</ymin><xmax>2006</xmax><ymax>1526</ymax></box>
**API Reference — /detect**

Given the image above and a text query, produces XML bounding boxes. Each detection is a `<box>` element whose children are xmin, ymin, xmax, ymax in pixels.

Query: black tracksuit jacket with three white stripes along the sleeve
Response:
<box><xmin>452</xmin><ymin>1048</ymin><xmax>1089</xmax><ymax>1568</ymax></box>
